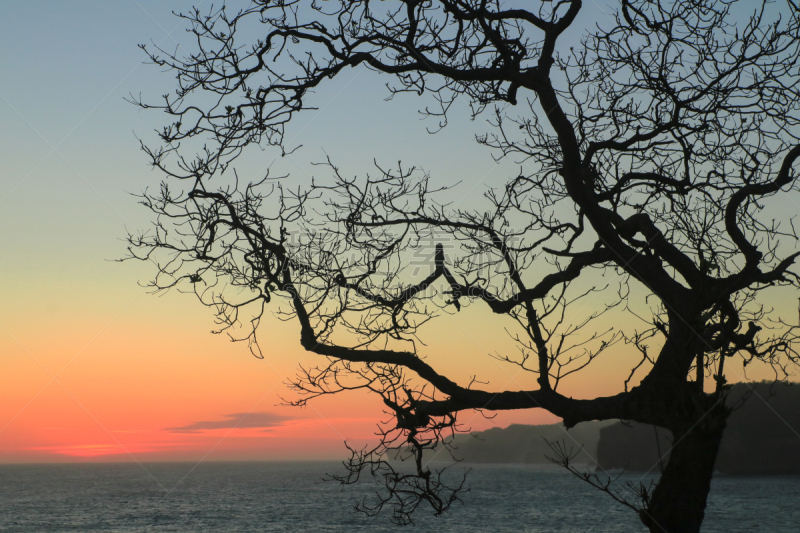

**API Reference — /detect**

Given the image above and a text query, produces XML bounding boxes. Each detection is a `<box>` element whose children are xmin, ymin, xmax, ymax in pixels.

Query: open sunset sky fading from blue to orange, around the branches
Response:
<box><xmin>0</xmin><ymin>0</ymin><xmax>793</xmax><ymax>463</ymax></box>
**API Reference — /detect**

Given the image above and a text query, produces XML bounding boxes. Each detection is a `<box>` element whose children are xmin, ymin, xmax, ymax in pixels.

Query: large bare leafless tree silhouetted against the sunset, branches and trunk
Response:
<box><xmin>130</xmin><ymin>0</ymin><xmax>800</xmax><ymax>532</ymax></box>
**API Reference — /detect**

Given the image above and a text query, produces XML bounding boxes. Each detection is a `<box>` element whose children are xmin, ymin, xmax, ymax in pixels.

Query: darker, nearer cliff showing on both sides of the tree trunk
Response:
<box><xmin>597</xmin><ymin>383</ymin><xmax>800</xmax><ymax>475</ymax></box>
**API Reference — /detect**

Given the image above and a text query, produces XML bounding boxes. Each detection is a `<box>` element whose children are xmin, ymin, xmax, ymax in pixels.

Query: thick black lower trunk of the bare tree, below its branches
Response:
<box><xmin>640</xmin><ymin>404</ymin><xmax>729</xmax><ymax>533</ymax></box>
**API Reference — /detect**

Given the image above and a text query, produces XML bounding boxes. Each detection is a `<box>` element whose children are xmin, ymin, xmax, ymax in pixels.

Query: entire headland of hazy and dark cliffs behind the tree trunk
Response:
<box><xmin>444</xmin><ymin>383</ymin><xmax>800</xmax><ymax>475</ymax></box>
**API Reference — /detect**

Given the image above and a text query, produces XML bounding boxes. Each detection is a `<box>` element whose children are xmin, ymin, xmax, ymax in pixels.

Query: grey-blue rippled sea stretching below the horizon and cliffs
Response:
<box><xmin>0</xmin><ymin>462</ymin><xmax>800</xmax><ymax>533</ymax></box>
